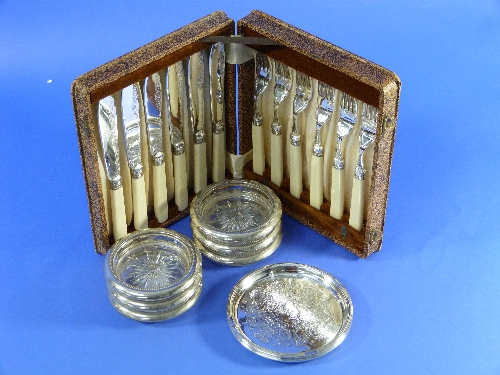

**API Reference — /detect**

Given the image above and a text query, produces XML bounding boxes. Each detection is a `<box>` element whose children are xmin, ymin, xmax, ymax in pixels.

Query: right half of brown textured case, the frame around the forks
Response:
<box><xmin>238</xmin><ymin>11</ymin><xmax>401</xmax><ymax>258</ymax></box>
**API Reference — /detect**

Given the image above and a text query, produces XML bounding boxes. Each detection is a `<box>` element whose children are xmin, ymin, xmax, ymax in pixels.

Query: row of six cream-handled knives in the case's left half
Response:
<box><xmin>97</xmin><ymin>43</ymin><xmax>226</xmax><ymax>241</ymax></box>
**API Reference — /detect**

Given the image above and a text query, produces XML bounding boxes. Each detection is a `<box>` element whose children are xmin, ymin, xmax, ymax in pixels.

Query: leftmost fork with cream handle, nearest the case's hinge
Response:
<box><xmin>252</xmin><ymin>52</ymin><xmax>271</xmax><ymax>175</ymax></box>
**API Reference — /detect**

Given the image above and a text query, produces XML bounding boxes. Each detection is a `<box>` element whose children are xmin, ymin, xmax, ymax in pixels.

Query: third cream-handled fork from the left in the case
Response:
<box><xmin>290</xmin><ymin>72</ymin><xmax>312</xmax><ymax>198</ymax></box>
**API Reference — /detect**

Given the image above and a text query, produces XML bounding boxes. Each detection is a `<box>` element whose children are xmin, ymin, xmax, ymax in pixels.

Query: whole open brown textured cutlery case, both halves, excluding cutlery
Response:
<box><xmin>72</xmin><ymin>11</ymin><xmax>401</xmax><ymax>258</ymax></box>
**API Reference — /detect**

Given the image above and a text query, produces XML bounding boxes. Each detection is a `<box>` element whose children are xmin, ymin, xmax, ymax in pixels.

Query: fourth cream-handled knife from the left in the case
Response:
<box><xmin>165</xmin><ymin>61</ymin><xmax>188</xmax><ymax>211</ymax></box>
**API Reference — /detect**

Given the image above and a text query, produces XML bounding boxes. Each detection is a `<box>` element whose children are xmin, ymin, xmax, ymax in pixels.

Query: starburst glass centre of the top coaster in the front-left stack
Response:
<box><xmin>122</xmin><ymin>249</ymin><xmax>186</xmax><ymax>290</ymax></box>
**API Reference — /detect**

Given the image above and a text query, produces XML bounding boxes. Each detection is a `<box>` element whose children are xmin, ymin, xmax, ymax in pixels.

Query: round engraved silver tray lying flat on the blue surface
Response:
<box><xmin>227</xmin><ymin>263</ymin><xmax>353</xmax><ymax>362</ymax></box>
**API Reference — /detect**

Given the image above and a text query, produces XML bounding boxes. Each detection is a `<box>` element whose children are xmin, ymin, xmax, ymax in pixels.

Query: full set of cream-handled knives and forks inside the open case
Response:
<box><xmin>97</xmin><ymin>47</ymin><xmax>378</xmax><ymax>240</ymax></box>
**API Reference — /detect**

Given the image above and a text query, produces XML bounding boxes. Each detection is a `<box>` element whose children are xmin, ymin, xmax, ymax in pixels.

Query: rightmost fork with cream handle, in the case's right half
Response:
<box><xmin>349</xmin><ymin>103</ymin><xmax>378</xmax><ymax>230</ymax></box>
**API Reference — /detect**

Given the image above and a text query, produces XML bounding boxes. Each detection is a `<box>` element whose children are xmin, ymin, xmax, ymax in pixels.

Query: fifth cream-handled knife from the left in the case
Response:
<box><xmin>190</xmin><ymin>51</ymin><xmax>207</xmax><ymax>193</ymax></box>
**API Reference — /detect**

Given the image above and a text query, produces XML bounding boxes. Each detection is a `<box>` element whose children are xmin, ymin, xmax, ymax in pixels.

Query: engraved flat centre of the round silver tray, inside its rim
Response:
<box><xmin>238</xmin><ymin>278</ymin><xmax>340</xmax><ymax>353</ymax></box>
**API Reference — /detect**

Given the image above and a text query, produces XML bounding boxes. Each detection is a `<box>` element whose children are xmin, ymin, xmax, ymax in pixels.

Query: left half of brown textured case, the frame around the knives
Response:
<box><xmin>71</xmin><ymin>12</ymin><xmax>235</xmax><ymax>254</ymax></box>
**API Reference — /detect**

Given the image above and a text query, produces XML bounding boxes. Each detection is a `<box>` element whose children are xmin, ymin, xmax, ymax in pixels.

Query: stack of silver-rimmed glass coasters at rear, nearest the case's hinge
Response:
<box><xmin>191</xmin><ymin>180</ymin><xmax>282</xmax><ymax>266</ymax></box>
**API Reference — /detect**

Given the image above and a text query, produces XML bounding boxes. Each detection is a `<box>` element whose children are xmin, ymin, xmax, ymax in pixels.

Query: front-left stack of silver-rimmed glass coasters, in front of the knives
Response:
<box><xmin>104</xmin><ymin>228</ymin><xmax>202</xmax><ymax>322</ymax></box>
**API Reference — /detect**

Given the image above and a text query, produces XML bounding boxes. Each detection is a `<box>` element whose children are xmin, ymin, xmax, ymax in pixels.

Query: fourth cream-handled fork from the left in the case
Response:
<box><xmin>309</xmin><ymin>82</ymin><xmax>336</xmax><ymax>210</ymax></box>
